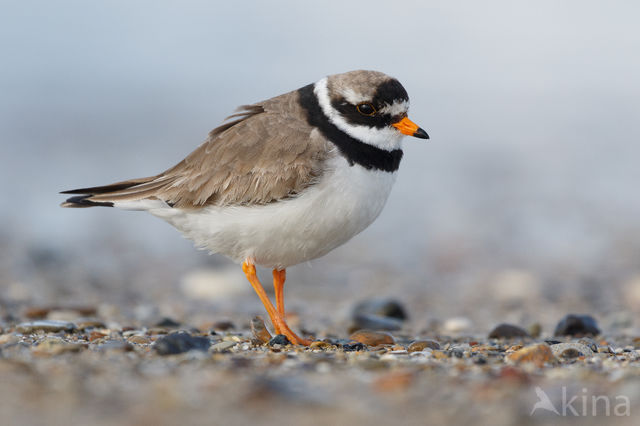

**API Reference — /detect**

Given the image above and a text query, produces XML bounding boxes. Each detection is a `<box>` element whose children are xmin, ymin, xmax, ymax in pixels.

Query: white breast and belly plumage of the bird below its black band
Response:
<box><xmin>149</xmin><ymin>156</ymin><xmax>396</xmax><ymax>268</ymax></box>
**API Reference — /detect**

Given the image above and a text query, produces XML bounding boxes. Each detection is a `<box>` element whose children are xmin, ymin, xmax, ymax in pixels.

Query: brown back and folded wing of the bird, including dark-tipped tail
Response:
<box><xmin>63</xmin><ymin>92</ymin><xmax>330</xmax><ymax>208</ymax></box>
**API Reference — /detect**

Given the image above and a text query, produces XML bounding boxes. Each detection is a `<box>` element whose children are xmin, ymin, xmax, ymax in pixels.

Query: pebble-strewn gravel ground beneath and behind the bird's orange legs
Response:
<box><xmin>0</xmin><ymin>238</ymin><xmax>640</xmax><ymax>425</ymax></box>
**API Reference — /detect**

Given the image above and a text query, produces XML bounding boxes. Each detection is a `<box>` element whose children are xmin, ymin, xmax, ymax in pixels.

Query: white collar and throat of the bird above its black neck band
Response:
<box><xmin>313</xmin><ymin>77</ymin><xmax>404</xmax><ymax>151</ymax></box>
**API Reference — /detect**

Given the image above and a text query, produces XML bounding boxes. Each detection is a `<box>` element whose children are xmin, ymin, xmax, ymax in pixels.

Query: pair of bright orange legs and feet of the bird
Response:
<box><xmin>242</xmin><ymin>261</ymin><xmax>311</xmax><ymax>346</ymax></box>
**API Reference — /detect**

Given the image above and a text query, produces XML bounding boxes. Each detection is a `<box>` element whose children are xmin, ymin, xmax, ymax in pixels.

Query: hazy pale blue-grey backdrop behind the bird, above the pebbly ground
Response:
<box><xmin>0</xmin><ymin>0</ymin><xmax>640</xmax><ymax>278</ymax></box>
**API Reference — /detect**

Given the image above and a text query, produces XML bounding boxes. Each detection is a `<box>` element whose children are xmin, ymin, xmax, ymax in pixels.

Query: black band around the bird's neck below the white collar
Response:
<box><xmin>298</xmin><ymin>84</ymin><xmax>402</xmax><ymax>172</ymax></box>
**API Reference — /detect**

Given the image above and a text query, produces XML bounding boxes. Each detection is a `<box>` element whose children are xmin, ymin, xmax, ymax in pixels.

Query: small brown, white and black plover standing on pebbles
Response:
<box><xmin>61</xmin><ymin>70</ymin><xmax>429</xmax><ymax>345</ymax></box>
